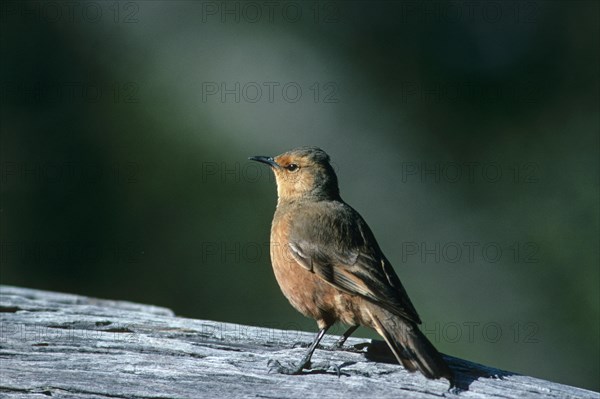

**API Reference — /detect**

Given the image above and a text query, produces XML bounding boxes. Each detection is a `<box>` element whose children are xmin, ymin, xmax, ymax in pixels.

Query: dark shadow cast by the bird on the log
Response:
<box><xmin>353</xmin><ymin>340</ymin><xmax>516</xmax><ymax>393</ymax></box>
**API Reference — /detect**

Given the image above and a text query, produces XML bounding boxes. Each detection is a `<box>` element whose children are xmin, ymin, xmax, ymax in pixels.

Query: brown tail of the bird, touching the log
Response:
<box><xmin>370</xmin><ymin>305</ymin><xmax>454</xmax><ymax>385</ymax></box>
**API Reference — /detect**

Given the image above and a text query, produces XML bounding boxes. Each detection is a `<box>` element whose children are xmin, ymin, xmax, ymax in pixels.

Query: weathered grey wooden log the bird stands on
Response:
<box><xmin>0</xmin><ymin>286</ymin><xmax>599</xmax><ymax>399</ymax></box>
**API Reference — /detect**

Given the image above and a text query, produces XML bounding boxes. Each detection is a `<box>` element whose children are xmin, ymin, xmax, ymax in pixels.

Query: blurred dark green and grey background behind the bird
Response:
<box><xmin>0</xmin><ymin>1</ymin><xmax>600</xmax><ymax>390</ymax></box>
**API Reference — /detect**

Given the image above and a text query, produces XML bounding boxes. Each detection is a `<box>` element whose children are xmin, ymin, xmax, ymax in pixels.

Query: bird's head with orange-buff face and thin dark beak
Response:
<box><xmin>249</xmin><ymin>147</ymin><xmax>340</xmax><ymax>201</ymax></box>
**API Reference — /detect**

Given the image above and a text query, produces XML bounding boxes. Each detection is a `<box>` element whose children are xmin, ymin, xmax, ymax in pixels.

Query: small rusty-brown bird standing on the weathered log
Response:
<box><xmin>249</xmin><ymin>147</ymin><xmax>453</xmax><ymax>384</ymax></box>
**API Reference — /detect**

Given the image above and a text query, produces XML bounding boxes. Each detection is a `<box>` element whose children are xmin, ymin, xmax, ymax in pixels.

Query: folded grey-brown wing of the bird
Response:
<box><xmin>288</xmin><ymin>202</ymin><xmax>421</xmax><ymax>323</ymax></box>
